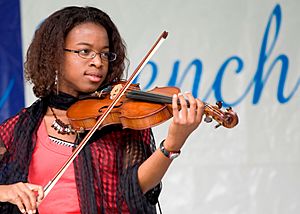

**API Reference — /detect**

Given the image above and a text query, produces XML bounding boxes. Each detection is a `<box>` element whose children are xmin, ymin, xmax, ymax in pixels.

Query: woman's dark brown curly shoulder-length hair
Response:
<box><xmin>24</xmin><ymin>6</ymin><xmax>127</xmax><ymax>97</ymax></box>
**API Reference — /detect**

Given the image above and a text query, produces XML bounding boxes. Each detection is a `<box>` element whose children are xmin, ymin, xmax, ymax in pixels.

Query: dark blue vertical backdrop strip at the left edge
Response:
<box><xmin>0</xmin><ymin>0</ymin><xmax>24</xmax><ymax>122</ymax></box>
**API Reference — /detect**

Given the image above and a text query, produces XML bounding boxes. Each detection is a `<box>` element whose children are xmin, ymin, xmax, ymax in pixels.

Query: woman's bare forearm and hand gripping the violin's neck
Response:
<box><xmin>138</xmin><ymin>93</ymin><xmax>204</xmax><ymax>193</ymax></box>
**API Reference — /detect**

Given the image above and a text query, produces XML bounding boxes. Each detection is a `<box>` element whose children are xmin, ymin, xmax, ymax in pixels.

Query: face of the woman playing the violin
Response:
<box><xmin>58</xmin><ymin>22</ymin><xmax>109</xmax><ymax>97</ymax></box>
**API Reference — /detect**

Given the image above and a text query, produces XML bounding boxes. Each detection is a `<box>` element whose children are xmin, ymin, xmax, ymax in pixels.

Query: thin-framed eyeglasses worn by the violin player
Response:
<box><xmin>64</xmin><ymin>48</ymin><xmax>117</xmax><ymax>62</ymax></box>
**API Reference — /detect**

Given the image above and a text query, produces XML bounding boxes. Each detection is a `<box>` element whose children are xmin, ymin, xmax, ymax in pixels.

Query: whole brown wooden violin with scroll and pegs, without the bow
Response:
<box><xmin>67</xmin><ymin>81</ymin><xmax>238</xmax><ymax>132</ymax></box>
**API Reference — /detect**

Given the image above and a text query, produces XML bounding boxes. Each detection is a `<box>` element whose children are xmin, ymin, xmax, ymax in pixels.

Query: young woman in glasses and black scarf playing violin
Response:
<box><xmin>0</xmin><ymin>7</ymin><xmax>204</xmax><ymax>214</ymax></box>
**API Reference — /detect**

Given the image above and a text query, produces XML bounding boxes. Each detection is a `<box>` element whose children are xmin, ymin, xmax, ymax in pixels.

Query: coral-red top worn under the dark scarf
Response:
<box><xmin>28</xmin><ymin>122</ymin><xmax>80</xmax><ymax>214</ymax></box>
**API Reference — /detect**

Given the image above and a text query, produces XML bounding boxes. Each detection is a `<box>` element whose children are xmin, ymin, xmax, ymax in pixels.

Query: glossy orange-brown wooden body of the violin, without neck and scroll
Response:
<box><xmin>67</xmin><ymin>83</ymin><xmax>180</xmax><ymax>131</ymax></box>
